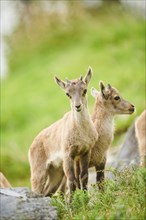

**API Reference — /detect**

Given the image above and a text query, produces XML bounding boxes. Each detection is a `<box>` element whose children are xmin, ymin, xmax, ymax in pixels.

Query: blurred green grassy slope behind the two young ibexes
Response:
<box><xmin>1</xmin><ymin>1</ymin><xmax>145</xmax><ymax>186</ymax></box>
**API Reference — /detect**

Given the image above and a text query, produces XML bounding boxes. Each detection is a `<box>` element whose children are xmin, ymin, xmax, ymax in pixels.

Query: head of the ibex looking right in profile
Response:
<box><xmin>91</xmin><ymin>81</ymin><xmax>135</xmax><ymax>114</ymax></box>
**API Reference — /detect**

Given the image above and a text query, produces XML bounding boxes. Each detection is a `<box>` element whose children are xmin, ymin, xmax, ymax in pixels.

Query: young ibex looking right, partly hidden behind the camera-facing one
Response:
<box><xmin>89</xmin><ymin>82</ymin><xmax>134</xmax><ymax>188</ymax></box>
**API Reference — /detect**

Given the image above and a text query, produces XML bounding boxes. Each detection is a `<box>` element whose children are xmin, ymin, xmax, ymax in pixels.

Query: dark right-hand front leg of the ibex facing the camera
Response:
<box><xmin>80</xmin><ymin>152</ymin><xmax>89</xmax><ymax>190</ymax></box>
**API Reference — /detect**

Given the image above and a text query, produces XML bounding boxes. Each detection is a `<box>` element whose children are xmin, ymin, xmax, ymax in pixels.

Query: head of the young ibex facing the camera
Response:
<box><xmin>55</xmin><ymin>67</ymin><xmax>92</xmax><ymax>112</ymax></box>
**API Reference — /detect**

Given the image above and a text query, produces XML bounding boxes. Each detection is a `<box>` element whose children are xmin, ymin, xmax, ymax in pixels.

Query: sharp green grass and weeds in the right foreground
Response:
<box><xmin>52</xmin><ymin>168</ymin><xmax>146</xmax><ymax>220</ymax></box>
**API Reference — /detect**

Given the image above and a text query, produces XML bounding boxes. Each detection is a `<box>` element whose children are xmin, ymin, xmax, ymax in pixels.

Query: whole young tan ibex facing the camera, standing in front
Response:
<box><xmin>29</xmin><ymin>68</ymin><xmax>98</xmax><ymax>198</ymax></box>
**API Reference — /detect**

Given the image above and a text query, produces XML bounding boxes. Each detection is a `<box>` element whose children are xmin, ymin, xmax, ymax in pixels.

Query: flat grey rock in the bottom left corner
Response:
<box><xmin>0</xmin><ymin>187</ymin><xmax>57</xmax><ymax>220</ymax></box>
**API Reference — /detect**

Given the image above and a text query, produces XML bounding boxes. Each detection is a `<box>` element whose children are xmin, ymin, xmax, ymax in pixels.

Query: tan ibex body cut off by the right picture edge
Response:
<box><xmin>135</xmin><ymin>110</ymin><xmax>146</xmax><ymax>167</ymax></box>
